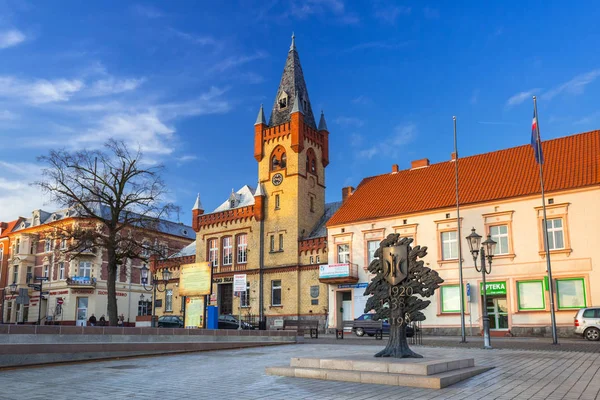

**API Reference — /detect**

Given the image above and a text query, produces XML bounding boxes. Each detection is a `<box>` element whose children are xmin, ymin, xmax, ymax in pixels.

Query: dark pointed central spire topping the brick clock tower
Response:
<box><xmin>269</xmin><ymin>34</ymin><xmax>317</xmax><ymax>129</ymax></box>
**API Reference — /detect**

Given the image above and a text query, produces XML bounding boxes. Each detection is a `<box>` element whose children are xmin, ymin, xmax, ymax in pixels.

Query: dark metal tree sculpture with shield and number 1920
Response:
<box><xmin>365</xmin><ymin>233</ymin><xmax>444</xmax><ymax>358</ymax></box>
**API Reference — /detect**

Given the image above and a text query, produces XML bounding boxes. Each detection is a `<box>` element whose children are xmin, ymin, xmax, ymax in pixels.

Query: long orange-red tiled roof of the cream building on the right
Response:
<box><xmin>327</xmin><ymin>131</ymin><xmax>600</xmax><ymax>227</ymax></box>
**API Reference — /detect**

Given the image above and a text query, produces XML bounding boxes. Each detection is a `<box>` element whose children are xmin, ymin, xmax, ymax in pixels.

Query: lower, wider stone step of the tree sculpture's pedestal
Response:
<box><xmin>266</xmin><ymin>366</ymin><xmax>492</xmax><ymax>389</ymax></box>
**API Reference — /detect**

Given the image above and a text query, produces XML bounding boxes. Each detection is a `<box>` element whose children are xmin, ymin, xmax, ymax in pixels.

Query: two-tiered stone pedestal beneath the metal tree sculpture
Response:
<box><xmin>266</xmin><ymin>355</ymin><xmax>492</xmax><ymax>389</ymax></box>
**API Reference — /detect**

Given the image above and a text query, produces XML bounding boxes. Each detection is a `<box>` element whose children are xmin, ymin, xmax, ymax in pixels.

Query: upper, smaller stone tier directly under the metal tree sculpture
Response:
<box><xmin>290</xmin><ymin>356</ymin><xmax>475</xmax><ymax>376</ymax></box>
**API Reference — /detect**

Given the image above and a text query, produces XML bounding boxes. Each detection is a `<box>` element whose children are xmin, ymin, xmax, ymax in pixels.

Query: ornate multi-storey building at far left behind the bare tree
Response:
<box><xmin>3</xmin><ymin>209</ymin><xmax>194</xmax><ymax>325</ymax></box>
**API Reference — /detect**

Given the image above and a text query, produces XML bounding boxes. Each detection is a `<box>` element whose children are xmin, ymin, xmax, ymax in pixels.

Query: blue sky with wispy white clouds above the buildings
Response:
<box><xmin>0</xmin><ymin>0</ymin><xmax>600</xmax><ymax>223</ymax></box>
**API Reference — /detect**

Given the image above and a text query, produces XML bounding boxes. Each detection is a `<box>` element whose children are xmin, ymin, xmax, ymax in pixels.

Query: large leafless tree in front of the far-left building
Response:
<box><xmin>35</xmin><ymin>139</ymin><xmax>176</xmax><ymax>325</ymax></box>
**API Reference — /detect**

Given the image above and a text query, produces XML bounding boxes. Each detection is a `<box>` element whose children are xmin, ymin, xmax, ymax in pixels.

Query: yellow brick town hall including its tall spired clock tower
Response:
<box><xmin>193</xmin><ymin>38</ymin><xmax>339</xmax><ymax>327</ymax></box>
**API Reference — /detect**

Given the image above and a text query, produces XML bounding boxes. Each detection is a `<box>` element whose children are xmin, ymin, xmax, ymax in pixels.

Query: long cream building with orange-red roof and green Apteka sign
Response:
<box><xmin>328</xmin><ymin>131</ymin><xmax>600</xmax><ymax>336</ymax></box>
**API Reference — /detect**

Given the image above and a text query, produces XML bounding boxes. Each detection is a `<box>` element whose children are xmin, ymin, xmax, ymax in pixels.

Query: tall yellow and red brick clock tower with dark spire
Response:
<box><xmin>254</xmin><ymin>36</ymin><xmax>329</xmax><ymax>267</ymax></box>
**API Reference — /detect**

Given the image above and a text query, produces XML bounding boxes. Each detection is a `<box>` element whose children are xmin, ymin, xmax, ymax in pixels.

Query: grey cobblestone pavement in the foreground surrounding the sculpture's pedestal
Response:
<box><xmin>0</xmin><ymin>342</ymin><xmax>600</xmax><ymax>400</ymax></box>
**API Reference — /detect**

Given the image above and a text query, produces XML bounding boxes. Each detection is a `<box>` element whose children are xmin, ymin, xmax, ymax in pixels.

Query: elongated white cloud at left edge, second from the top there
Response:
<box><xmin>0</xmin><ymin>76</ymin><xmax>85</xmax><ymax>104</ymax></box>
